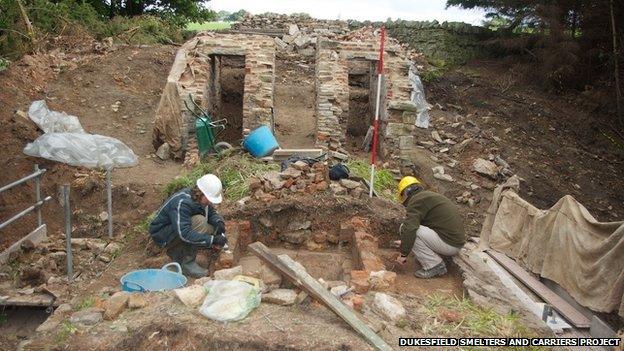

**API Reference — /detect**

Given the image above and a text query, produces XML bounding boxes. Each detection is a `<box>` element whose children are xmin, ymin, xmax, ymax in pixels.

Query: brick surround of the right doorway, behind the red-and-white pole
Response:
<box><xmin>316</xmin><ymin>40</ymin><xmax>416</xmax><ymax>165</ymax></box>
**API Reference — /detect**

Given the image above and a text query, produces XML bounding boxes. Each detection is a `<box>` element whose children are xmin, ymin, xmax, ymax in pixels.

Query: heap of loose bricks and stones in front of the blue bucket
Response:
<box><xmin>249</xmin><ymin>161</ymin><xmax>330</xmax><ymax>201</ymax></box>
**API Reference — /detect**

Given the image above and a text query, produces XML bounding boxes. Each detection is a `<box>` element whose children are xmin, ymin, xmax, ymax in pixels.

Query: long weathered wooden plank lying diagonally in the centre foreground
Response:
<box><xmin>248</xmin><ymin>242</ymin><xmax>392</xmax><ymax>350</ymax></box>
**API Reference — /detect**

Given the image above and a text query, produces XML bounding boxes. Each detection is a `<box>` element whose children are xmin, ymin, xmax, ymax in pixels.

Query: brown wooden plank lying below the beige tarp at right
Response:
<box><xmin>487</xmin><ymin>250</ymin><xmax>590</xmax><ymax>329</ymax></box>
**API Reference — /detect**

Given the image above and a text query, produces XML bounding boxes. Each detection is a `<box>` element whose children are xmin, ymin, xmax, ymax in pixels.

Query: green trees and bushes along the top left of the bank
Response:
<box><xmin>0</xmin><ymin>0</ymin><xmax>215</xmax><ymax>58</ymax></box>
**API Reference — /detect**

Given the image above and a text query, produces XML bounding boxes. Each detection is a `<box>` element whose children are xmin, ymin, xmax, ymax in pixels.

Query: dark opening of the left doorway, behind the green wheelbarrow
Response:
<box><xmin>207</xmin><ymin>55</ymin><xmax>245</xmax><ymax>145</ymax></box>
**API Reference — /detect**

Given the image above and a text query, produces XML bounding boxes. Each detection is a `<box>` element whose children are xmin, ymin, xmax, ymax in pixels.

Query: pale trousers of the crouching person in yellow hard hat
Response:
<box><xmin>412</xmin><ymin>225</ymin><xmax>461</xmax><ymax>269</ymax></box>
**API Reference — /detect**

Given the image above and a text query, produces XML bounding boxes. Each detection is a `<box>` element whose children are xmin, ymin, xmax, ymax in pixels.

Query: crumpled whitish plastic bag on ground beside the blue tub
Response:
<box><xmin>199</xmin><ymin>280</ymin><xmax>260</xmax><ymax>322</ymax></box>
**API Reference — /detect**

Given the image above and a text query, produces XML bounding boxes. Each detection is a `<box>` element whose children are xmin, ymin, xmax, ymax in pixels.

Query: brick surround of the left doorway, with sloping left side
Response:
<box><xmin>154</xmin><ymin>33</ymin><xmax>275</xmax><ymax>162</ymax></box>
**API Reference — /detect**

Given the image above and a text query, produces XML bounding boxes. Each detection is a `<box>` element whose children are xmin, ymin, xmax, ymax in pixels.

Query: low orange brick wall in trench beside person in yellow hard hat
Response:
<box><xmin>340</xmin><ymin>217</ymin><xmax>396</xmax><ymax>294</ymax></box>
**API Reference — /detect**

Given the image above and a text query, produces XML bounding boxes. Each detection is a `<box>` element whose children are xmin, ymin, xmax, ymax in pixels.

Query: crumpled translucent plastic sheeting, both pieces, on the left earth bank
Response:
<box><xmin>24</xmin><ymin>100</ymin><xmax>139</xmax><ymax>169</ymax></box>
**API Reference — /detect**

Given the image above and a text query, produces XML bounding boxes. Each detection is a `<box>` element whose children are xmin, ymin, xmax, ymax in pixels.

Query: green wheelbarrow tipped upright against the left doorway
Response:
<box><xmin>184</xmin><ymin>94</ymin><xmax>232</xmax><ymax>157</ymax></box>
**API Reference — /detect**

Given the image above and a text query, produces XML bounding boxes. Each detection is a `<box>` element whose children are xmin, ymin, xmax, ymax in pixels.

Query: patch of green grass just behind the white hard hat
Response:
<box><xmin>163</xmin><ymin>153</ymin><xmax>279</xmax><ymax>201</ymax></box>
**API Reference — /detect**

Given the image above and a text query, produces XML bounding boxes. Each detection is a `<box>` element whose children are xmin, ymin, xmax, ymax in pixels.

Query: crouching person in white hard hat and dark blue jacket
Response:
<box><xmin>149</xmin><ymin>174</ymin><xmax>227</xmax><ymax>278</ymax></box>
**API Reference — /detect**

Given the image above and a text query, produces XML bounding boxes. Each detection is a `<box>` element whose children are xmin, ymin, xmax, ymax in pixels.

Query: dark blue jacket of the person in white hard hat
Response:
<box><xmin>149</xmin><ymin>188</ymin><xmax>223</xmax><ymax>247</ymax></box>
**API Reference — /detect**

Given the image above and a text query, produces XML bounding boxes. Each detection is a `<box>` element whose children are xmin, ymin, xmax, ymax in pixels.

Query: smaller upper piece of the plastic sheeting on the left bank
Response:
<box><xmin>28</xmin><ymin>100</ymin><xmax>85</xmax><ymax>133</ymax></box>
